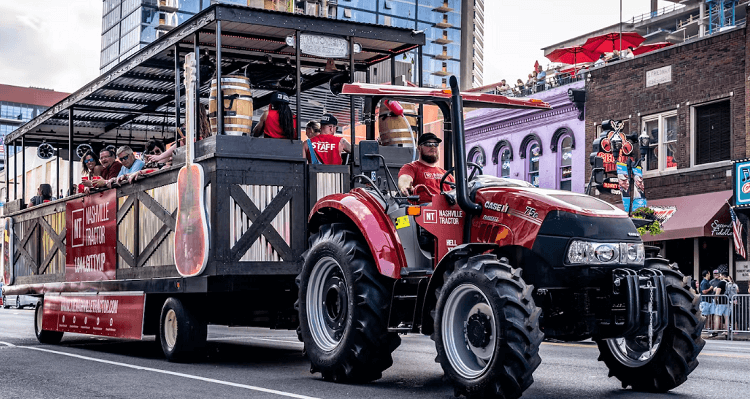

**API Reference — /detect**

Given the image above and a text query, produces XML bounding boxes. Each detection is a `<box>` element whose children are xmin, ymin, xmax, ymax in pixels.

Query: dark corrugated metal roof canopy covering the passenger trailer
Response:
<box><xmin>5</xmin><ymin>4</ymin><xmax>425</xmax><ymax>148</ymax></box>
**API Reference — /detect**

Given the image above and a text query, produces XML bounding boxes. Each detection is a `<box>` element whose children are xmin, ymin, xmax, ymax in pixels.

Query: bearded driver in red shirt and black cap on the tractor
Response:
<box><xmin>398</xmin><ymin>133</ymin><xmax>454</xmax><ymax>198</ymax></box>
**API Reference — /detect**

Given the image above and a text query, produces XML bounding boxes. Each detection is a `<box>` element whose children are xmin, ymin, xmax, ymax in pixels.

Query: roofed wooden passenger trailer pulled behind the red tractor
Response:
<box><xmin>2</xmin><ymin>4</ymin><xmax>425</xmax><ymax>360</ymax></box>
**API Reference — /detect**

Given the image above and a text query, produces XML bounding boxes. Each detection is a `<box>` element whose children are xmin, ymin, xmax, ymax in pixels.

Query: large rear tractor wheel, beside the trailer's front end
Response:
<box><xmin>296</xmin><ymin>223</ymin><xmax>401</xmax><ymax>382</ymax></box>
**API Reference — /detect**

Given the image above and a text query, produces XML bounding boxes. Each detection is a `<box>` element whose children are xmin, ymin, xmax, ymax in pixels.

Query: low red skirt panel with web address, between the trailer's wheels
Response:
<box><xmin>42</xmin><ymin>292</ymin><xmax>146</xmax><ymax>339</ymax></box>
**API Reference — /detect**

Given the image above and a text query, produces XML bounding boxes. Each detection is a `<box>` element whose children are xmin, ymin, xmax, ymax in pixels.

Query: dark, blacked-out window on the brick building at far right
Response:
<box><xmin>694</xmin><ymin>101</ymin><xmax>732</xmax><ymax>165</ymax></box>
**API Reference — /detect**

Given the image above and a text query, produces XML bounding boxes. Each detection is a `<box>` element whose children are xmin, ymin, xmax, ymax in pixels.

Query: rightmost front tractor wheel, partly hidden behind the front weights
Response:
<box><xmin>596</xmin><ymin>258</ymin><xmax>706</xmax><ymax>392</ymax></box>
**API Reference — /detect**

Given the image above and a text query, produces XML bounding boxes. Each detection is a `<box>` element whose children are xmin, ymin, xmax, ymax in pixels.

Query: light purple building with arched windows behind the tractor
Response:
<box><xmin>465</xmin><ymin>81</ymin><xmax>589</xmax><ymax>193</ymax></box>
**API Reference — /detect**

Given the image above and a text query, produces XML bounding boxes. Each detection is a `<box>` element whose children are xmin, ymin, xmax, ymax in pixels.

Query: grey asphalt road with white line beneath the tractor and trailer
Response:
<box><xmin>0</xmin><ymin>309</ymin><xmax>750</xmax><ymax>399</ymax></box>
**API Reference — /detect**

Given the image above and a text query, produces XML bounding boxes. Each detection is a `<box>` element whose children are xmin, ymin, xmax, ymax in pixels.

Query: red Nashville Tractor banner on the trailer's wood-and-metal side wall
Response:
<box><xmin>65</xmin><ymin>190</ymin><xmax>117</xmax><ymax>281</ymax></box>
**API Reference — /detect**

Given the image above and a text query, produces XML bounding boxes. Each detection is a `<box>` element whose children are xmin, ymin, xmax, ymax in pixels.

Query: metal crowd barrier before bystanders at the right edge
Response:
<box><xmin>700</xmin><ymin>294</ymin><xmax>750</xmax><ymax>340</ymax></box>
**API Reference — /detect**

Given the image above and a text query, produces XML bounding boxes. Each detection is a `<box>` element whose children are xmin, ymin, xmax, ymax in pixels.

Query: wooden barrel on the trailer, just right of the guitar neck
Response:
<box><xmin>208</xmin><ymin>75</ymin><xmax>253</xmax><ymax>136</ymax></box>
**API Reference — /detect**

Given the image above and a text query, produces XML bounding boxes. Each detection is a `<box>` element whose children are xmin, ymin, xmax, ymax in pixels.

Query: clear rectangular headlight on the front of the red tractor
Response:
<box><xmin>567</xmin><ymin>240</ymin><xmax>645</xmax><ymax>265</ymax></box>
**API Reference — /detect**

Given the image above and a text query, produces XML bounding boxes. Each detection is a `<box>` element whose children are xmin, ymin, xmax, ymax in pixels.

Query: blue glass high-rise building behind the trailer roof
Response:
<box><xmin>100</xmin><ymin>0</ymin><xmax>484</xmax><ymax>88</ymax></box>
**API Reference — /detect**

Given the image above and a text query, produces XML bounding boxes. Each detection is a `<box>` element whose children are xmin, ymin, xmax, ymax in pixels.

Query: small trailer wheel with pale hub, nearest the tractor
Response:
<box><xmin>159</xmin><ymin>297</ymin><xmax>208</xmax><ymax>362</ymax></box>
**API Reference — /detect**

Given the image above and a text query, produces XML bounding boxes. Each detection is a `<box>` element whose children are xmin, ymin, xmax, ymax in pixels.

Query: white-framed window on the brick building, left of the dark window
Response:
<box><xmin>642</xmin><ymin>111</ymin><xmax>677</xmax><ymax>170</ymax></box>
